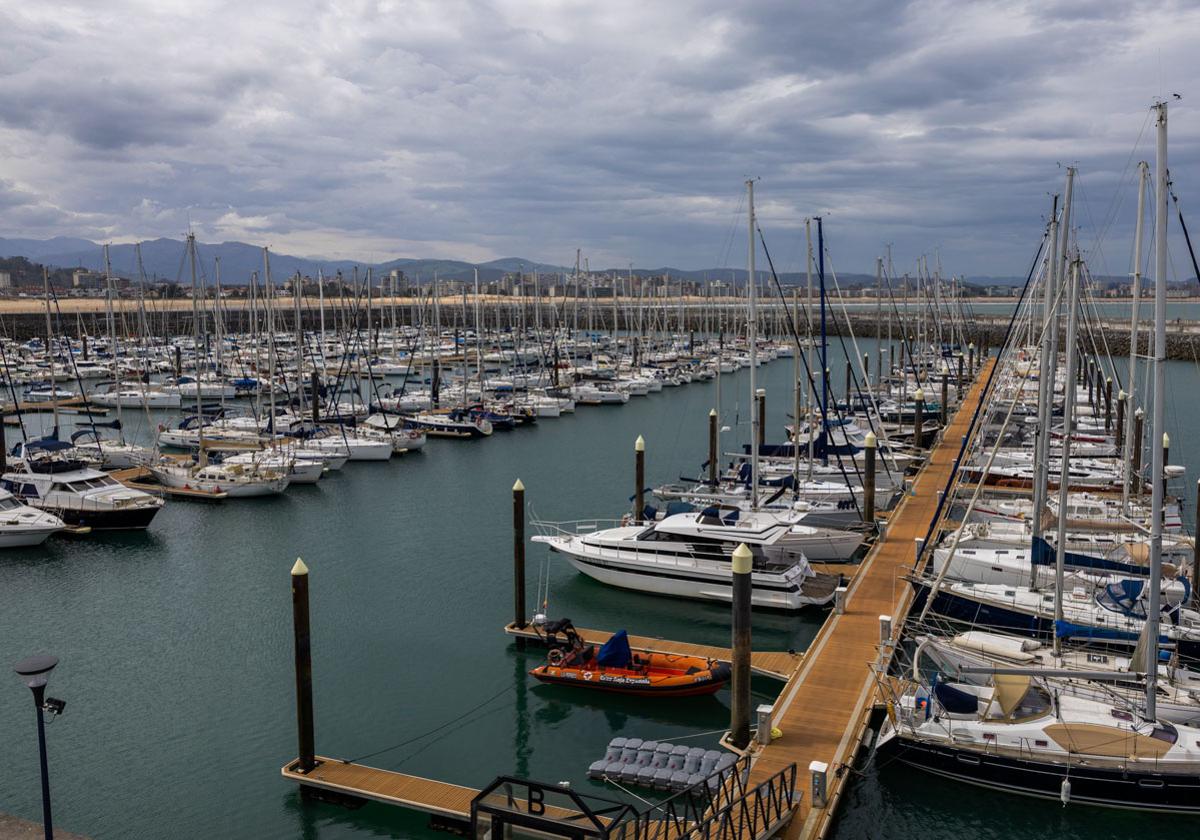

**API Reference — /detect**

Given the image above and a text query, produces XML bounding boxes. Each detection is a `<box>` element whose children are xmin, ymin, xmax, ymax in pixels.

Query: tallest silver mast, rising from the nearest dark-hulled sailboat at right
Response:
<box><xmin>1146</xmin><ymin>102</ymin><xmax>1169</xmax><ymax>720</ymax></box>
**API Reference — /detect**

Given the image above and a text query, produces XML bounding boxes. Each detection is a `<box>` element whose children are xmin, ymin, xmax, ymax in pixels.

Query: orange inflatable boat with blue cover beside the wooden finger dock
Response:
<box><xmin>529</xmin><ymin>623</ymin><xmax>730</xmax><ymax>697</ymax></box>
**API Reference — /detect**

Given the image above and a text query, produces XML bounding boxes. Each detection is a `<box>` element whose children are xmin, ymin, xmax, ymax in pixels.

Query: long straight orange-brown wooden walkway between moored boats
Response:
<box><xmin>750</xmin><ymin>359</ymin><xmax>995</xmax><ymax>840</ymax></box>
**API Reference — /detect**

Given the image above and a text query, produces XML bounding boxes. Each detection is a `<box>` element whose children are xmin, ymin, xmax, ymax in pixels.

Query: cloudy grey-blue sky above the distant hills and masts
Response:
<box><xmin>0</xmin><ymin>0</ymin><xmax>1200</xmax><ymax>275</ymax></box>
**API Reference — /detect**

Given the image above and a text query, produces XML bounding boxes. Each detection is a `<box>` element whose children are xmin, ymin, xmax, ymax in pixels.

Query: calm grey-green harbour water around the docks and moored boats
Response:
<box><xmin>0</xmin><ymin>343</ymin><xmax>1200</xmax><ymax>840</ymax></box>
